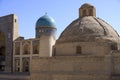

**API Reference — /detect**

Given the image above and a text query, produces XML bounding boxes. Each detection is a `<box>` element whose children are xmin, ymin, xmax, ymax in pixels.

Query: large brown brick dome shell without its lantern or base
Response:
<box><xmin>57</xmin><ymin>16</ymin><xmax>119</xmax><ymax>42</ymax></box>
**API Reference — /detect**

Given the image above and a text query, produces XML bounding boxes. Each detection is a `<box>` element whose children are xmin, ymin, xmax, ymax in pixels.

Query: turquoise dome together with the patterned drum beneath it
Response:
<box><xmin>36</xmin><ymin>14</ymin><xmax>57</xmax><ymax>38</ymax></box>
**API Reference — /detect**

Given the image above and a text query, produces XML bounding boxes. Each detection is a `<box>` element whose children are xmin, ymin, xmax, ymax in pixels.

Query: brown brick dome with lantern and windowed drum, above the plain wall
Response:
<box><xmin>55</xmin><ymin>4</ymin><xmax>119</xmax><ymax>56</ymax></box>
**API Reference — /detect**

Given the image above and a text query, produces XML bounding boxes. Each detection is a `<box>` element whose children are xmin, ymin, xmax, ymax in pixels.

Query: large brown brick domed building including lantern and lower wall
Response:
<box><xmin>31</xmin><ymin>3</ymin><xmax>120</xmax><ymax>80</ymax></box>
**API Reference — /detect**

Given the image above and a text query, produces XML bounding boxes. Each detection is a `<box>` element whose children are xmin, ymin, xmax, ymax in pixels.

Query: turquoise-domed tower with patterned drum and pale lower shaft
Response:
<box><xmin>36</xmin><ymin>14</ymin><xmax>57</xmax><ymax>57</ymax></box>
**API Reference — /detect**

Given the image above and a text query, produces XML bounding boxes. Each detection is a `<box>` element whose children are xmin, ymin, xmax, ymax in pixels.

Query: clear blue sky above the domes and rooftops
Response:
<box><xmin>0</xmin><ymin>0</ymin><xmax>120</xmax><ymax>38</ymax></box>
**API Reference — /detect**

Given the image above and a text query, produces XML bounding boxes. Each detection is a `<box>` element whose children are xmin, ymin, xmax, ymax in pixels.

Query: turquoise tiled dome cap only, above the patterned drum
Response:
<box><xmin>36</xmin><ymin>14</ymin><xmax>56</xmax><ymax>28</ymax></box>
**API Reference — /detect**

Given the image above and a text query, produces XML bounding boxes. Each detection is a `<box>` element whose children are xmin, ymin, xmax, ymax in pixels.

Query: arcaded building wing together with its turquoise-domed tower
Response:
<box><xmin>13</xmin><ymin>14</ymin><xmax>56</xmax><ymax>72</ymax></box>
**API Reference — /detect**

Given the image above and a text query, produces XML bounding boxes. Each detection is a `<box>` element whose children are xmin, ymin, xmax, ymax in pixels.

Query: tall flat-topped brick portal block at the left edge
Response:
<box><xmin>0</xmin><ymin>14</ymin><xmax>18</xmax><ymax>72</ymax></box>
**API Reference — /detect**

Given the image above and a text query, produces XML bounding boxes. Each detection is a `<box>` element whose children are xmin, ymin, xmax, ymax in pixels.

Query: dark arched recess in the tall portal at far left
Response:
<box><xmin>0</xmin><ymin>31</ymin><xmax>5</xmax><ymax>71</ymax></box>
